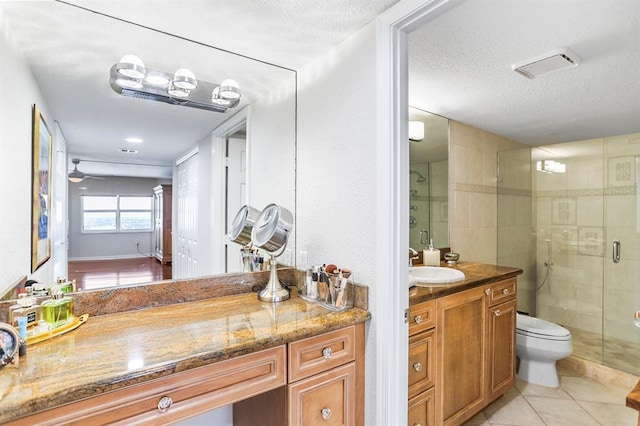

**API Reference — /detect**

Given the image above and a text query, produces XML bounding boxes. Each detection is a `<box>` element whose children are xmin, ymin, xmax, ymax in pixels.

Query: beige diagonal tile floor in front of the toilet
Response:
<box><xmin>465</xmin><ymin>368</ymin><xmax>638</xmax><ymax>426</ymax></box>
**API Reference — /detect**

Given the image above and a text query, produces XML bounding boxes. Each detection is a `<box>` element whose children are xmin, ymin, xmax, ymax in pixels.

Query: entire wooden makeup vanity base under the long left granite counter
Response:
<box><xmin>11</xmin><ymin>323</ymin><xmax>365</xmax><ymax>426</ymax></box>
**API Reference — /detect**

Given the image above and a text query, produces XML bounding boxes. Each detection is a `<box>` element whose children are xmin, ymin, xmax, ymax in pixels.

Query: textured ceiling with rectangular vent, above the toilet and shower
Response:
<box><xmin>409</xmin><ymin>0</ymin><xmax>640</xmax><ymax>145</ymax></box>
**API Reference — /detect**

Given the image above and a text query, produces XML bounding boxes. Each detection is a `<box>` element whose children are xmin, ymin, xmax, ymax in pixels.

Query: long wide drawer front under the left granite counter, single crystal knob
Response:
<box><xmin>11</xmin><ymin>345</ymin><xmax>286</xmax><ymax>426</ymax></box>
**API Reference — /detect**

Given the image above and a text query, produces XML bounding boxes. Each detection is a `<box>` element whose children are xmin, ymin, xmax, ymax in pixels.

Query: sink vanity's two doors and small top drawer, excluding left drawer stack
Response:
<box><xmin>436</xmin><ymin>278</ymin><xmax>516</xmax><ymax>425</ymax></box>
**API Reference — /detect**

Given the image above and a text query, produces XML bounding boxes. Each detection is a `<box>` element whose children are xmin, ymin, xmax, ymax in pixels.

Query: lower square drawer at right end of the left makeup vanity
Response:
<box><xmin>289</xmin><ymin>363</ymin><xmax>356</xmax><ymax>426</ymax></box>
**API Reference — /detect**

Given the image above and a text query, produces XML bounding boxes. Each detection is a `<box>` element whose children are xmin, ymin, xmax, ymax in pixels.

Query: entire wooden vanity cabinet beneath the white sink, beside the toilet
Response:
<box><xmin>408</xmin><ymin>278</ymin><xmax>516</xmax><ymax>426</ymax></box>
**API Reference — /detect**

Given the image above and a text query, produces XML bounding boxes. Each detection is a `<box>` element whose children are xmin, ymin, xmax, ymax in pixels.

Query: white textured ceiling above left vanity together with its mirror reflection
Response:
<box><xmin>0</xmin><ymin>0</ymin><xmax>397</xmax><ymax>176</ymax></box>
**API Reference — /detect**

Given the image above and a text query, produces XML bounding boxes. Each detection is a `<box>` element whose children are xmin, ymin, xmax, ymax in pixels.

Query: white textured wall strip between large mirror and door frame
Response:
<box><xmin>297</xmin><ymin>24</ymin><xmax>380</xmax><ymax>425</ymax></box>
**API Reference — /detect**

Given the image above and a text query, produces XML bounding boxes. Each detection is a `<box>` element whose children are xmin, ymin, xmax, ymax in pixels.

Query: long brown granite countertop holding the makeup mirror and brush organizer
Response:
<box><xmin>0</xmin><ymin>293</ymin><xmax>370</xmax><ymax>423</ymax></box>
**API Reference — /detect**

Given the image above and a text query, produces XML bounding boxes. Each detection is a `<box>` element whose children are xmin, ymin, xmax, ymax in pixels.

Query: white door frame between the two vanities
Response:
<box><xmin>368</xmin><ymin>0</ymin><xmax>464</xmax><ymax>424</ymax></box>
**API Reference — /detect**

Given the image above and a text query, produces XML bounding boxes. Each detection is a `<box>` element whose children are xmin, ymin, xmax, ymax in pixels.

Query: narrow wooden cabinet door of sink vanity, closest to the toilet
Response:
<box><xmin>488</xmin><ymin>299</ymin><xmax>516</xmax><ymax>400</ymax></box>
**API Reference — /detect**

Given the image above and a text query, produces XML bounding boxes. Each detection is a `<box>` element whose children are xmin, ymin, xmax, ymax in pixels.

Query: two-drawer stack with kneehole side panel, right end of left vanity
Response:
<box><xmin>233</xmin><ymin>324</ymin><xmax>364</xmax><ymax>426</ymax></box>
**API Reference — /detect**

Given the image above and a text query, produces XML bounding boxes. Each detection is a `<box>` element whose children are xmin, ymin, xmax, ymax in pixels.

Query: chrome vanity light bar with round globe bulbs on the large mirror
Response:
<box><xmin>109</xmin><ymin>55</ymin><xmax>242</xmax><ymax>113</ymax></box>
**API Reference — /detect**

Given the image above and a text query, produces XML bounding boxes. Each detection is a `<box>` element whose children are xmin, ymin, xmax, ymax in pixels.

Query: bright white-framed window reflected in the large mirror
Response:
<box><xmin>82</xmin><ymin>195</ymin><xmax>153</xmax><ymax>232</ymax></box>
